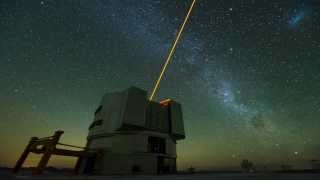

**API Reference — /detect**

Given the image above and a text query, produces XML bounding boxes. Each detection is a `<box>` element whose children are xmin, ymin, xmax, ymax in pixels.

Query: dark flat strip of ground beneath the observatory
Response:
<box><xmin>0</xmin><ymin>171</ymin><xmax>320</xmax><ymax>180</ymax></box>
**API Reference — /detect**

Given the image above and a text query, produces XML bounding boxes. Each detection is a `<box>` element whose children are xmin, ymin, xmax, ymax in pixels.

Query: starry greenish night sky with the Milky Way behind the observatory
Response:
<box><xmin>0</xmin><ymin>0</ymin><xmax>320</xmax><ymax>169</ymax></box>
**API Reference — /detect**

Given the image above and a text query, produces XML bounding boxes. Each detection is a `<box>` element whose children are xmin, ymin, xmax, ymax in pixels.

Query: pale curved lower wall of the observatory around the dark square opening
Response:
<box><xmin>82</xmin><ymin>131</ymin><xmax>176</xmax><ymax>174</ymax></box>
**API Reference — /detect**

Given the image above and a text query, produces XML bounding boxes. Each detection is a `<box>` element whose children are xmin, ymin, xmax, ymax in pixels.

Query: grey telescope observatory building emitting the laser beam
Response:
<box><xmin>79</xmin><ymin>87</ymin><xmax>185</xmax><ymax>174</ymax></box>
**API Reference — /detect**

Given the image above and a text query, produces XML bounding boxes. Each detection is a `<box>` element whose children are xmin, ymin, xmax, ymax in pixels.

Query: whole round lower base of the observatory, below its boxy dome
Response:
<box><xmin>80</xmin><ymin>131</ymin><xmax>176</xmax><ymax>175</ymax></box>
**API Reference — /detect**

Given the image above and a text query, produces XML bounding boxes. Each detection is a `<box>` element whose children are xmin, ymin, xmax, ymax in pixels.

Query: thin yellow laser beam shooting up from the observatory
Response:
<box><xmin>149</xmin><ymin>0</ymin><xmax>196</xmax><ymax>101</ymax></box>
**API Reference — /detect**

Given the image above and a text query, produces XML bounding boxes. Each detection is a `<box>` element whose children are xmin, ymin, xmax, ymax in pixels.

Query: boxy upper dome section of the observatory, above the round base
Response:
<box><xmin>89</xmin><ymin>87</ymin><xmax>185</xmax><ymax>140</ymax></box>
